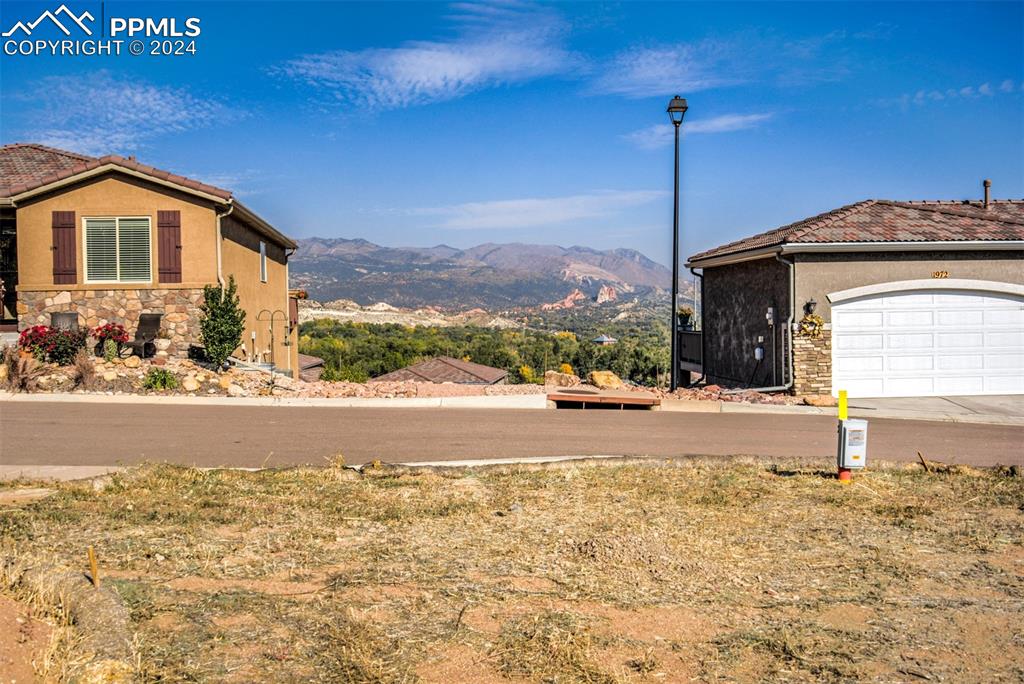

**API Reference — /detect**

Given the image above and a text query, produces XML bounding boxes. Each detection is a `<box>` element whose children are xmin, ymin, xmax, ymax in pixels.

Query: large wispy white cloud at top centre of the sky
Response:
<box><xmin>273</xmin><ymin>1</ymin><xmax>579</xmax><ymax>110</ymax></box>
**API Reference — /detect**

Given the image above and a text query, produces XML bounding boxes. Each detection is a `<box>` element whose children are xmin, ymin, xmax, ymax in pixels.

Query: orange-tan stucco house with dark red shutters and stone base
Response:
<box><xmin>0</xmin><ymin>143</ymin><xmax>298</xmax><ymax>374</ymax></box>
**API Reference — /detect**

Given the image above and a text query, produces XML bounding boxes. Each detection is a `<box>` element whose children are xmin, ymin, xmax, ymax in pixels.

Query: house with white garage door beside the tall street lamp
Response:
<box><xmin>679</xmin><ymin>187</ymin><xmax>1024</xmax><ymax>397</ymax></box>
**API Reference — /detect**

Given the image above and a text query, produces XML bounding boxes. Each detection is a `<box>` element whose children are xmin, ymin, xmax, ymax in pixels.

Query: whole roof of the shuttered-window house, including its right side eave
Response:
<box><xmin>0</xmin><ymin>142</ymin><xmax>298</xmax><ymax>249</ymax></box>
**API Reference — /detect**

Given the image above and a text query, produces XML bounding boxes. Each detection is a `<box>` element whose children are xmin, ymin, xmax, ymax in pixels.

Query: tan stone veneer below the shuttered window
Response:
<box><xmin>17</xmin><ymin>289</ymin><xmax>203</xmax><ymax>358</ymax></box>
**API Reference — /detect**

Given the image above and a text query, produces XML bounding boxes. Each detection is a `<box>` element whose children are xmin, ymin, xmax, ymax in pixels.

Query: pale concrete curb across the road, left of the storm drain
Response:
<box><xmin>0</xmin><ymin>392</ymin><xmax>548</xmax><ymax>409</ymax></box>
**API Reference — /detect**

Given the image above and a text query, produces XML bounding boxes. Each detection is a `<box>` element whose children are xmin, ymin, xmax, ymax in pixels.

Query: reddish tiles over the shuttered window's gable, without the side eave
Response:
<box><xmin>0</xmin><ymin>142</ymin><xmax>231</xmax><ymax>200</ymax></box>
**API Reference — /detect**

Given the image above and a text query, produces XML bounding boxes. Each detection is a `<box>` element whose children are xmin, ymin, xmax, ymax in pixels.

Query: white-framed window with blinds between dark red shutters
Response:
<box><xmin>85</xmin><ymin>216</ymin><xmax>153</xmax><ymax>283</ymax></box>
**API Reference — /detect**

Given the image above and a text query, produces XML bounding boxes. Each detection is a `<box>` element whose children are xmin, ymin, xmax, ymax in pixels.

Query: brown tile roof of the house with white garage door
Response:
<box><xmin>688</xmin><ymin>200</ymin><xmax>1024</xmax><ymax>263</ymax></box>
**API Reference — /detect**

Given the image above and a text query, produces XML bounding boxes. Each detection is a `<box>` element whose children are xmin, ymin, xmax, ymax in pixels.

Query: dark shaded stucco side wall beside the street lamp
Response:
<box><xmin>702</xmin><ymin>258</ymin><xmax>790</xmax><ymax>387</ymax></box>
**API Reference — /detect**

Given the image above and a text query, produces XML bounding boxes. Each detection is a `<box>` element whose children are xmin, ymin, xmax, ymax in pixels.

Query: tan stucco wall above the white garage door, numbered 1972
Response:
<box><xmin>794</xmin><ymin>251</ymin><xmax>1024</xmax><ymax>322</ymax></box>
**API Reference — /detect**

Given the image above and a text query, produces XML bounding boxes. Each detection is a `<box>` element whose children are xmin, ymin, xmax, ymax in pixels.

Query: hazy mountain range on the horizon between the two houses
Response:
<box><xmin>289</xmin><ymin>238</ymin><xmax>672</xmax><ymax>310</ymax></box>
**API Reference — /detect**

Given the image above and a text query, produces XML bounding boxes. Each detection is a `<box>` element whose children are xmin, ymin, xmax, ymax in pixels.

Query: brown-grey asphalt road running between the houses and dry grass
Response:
<box><xmin>0</xmin><ymin>402</ymin><xmax>1024</xmax><ymax>467</ymax></box>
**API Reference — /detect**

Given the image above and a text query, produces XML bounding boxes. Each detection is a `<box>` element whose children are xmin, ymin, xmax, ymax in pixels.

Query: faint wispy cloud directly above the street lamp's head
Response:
<box><xmin>590</xmin><ymin>32</ymin><xmax>849</xmax><ymax>97</ymax></box>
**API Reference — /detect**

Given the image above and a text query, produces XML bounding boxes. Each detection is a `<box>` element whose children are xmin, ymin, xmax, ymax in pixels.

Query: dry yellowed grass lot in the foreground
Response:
<box><xmin>0</xmin><ymin>461</ymin><xmax>1024</xmax><ymax>682</ymax></box>
